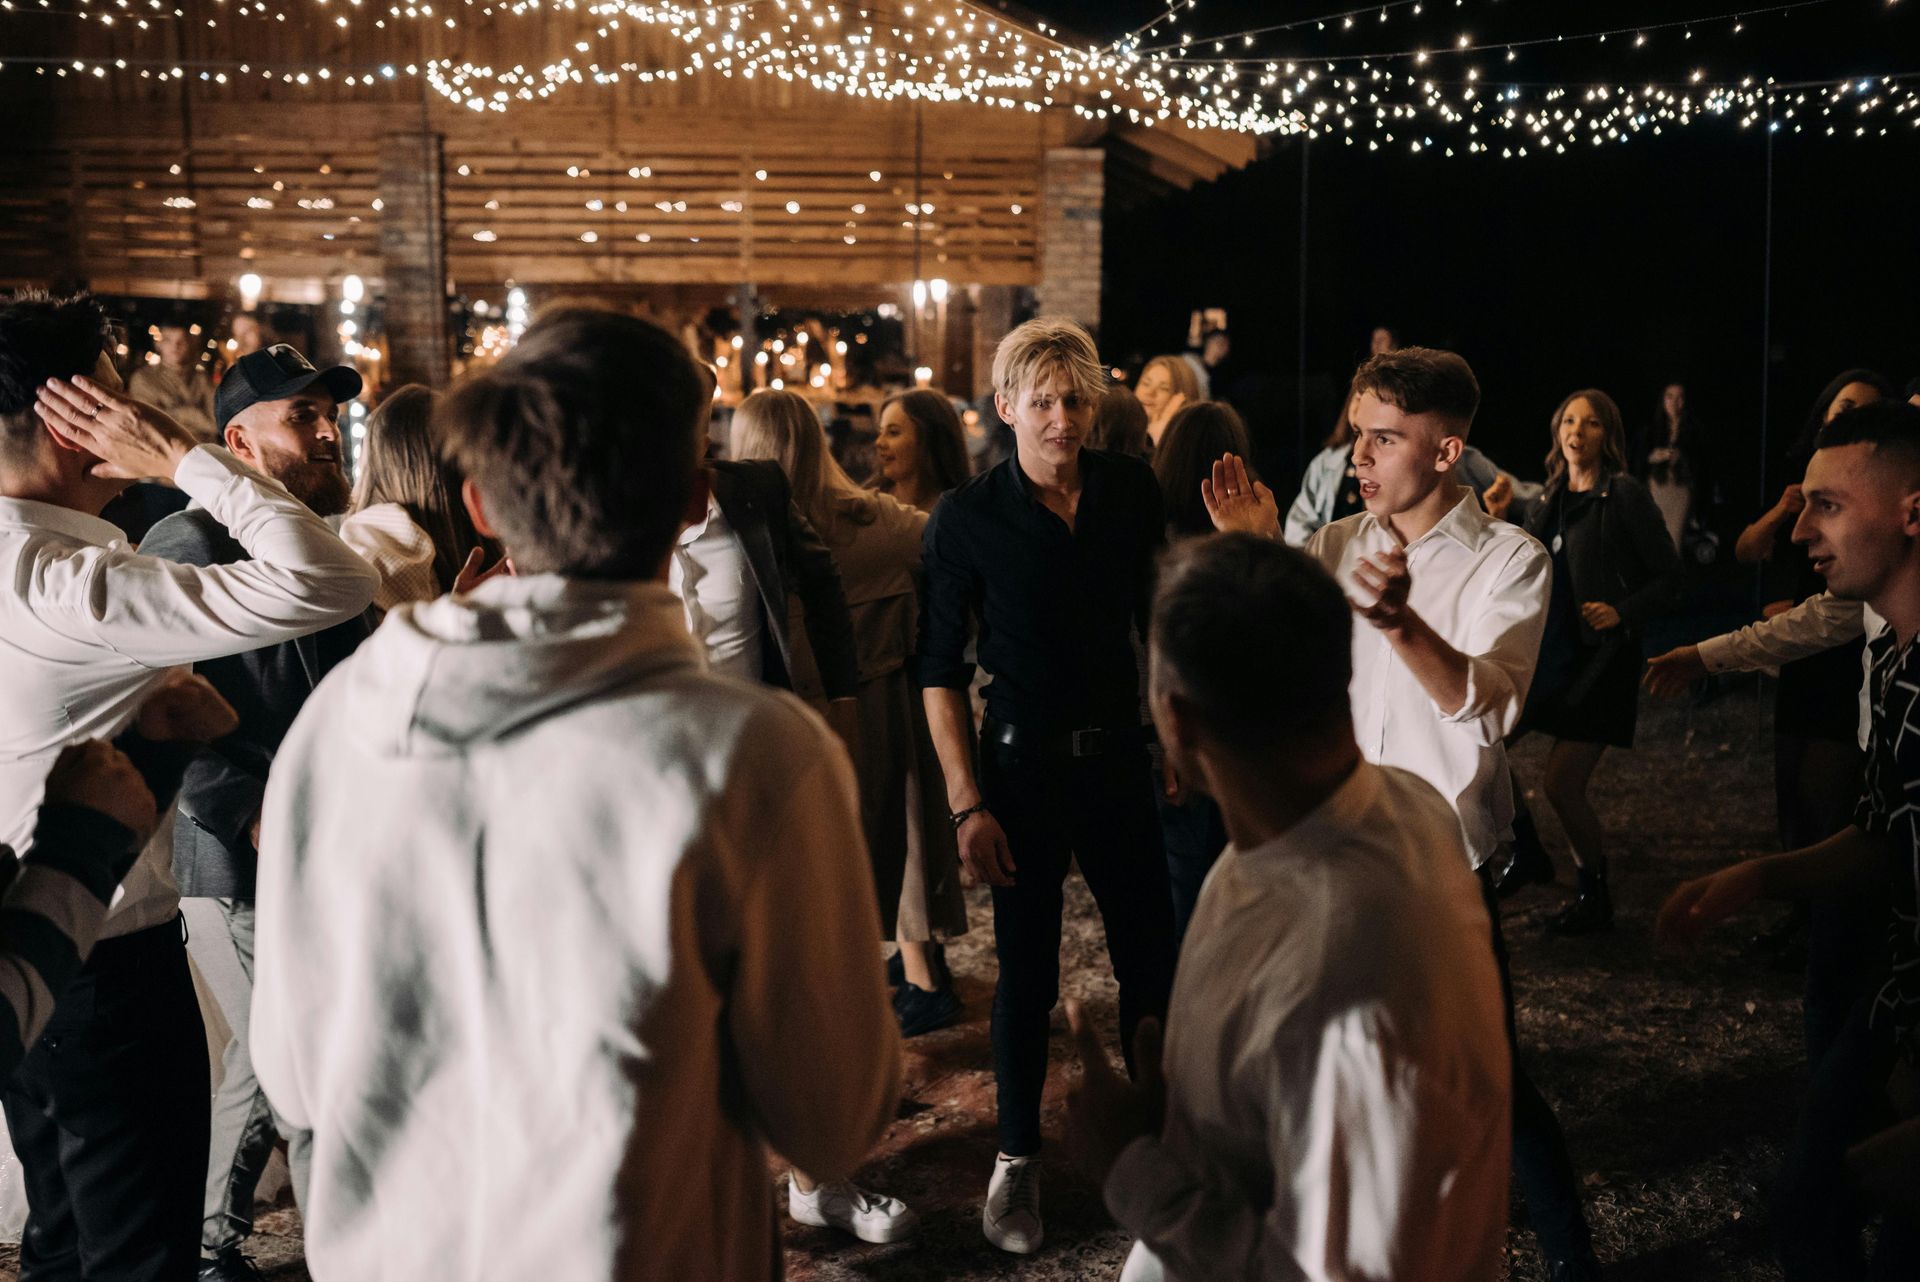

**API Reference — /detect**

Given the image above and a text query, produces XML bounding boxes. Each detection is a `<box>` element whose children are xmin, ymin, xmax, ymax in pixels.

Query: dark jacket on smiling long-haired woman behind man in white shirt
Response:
<box><xmin>1526</xmin><ymin>472</ymin><xmax>1682</xmax><ymax>641</ymax></box>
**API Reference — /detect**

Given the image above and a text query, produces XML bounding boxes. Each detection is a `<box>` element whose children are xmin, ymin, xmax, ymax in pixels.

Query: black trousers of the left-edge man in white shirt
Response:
<box><xmin>4</xmin><ymin>917</ymin><xmax>209</xmax><ymax>1282</ymax></box>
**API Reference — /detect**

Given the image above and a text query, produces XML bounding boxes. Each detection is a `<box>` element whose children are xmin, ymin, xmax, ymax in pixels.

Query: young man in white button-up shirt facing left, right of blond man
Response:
<box><xmin>1202</xmin><ymin>347</ymin><xmax>1599</xmax><ymax>1282</ymax></box>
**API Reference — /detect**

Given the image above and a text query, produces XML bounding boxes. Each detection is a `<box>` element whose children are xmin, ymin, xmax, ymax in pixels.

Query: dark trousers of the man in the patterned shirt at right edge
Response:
<box><xmin>1774</xmin><ymin>1000</ymin><xmax>1920</xmax><ymax>1282</ymax></box>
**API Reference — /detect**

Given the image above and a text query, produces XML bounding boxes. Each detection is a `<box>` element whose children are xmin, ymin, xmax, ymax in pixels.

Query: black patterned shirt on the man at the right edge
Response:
<box><xmin>1853</xmin><ymin>626</ymin><xmax>1920</xmax><ymax>1042</ymax></box>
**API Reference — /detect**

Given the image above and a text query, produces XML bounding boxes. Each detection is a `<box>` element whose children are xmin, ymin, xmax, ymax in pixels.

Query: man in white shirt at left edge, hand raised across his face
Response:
<box><xmin>0</xmin><ymin>296</ymin><xmax>374</xmax><ymax>1282</ymax></box>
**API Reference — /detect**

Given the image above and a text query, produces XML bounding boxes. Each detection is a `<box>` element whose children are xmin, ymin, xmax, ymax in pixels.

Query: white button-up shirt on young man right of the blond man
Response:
<box><xmin>1306</xmin><ymin>489</ymin><xmax>1553</xmax><ymax>867</ymax></box>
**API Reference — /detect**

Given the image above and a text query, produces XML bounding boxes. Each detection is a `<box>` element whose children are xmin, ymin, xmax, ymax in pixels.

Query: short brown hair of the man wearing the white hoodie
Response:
<box><xmin>434</xmin><ymin>307</ymin><xmax>708</xmax><ymax>580</ymax></box>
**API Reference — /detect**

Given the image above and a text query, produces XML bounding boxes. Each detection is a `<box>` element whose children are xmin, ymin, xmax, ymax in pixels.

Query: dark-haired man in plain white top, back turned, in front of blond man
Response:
<box><xmin>1069</xmin><ymin>534</ymin><xmax>1509</xmax><ymax>1282</ymax></box>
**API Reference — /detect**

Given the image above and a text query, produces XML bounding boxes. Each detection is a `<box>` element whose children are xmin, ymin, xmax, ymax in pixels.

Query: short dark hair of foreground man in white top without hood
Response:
<box><xmin>1152</xmin><ymin>534</ymin><xmax>1354</xmax><ymax>752</ymax></box>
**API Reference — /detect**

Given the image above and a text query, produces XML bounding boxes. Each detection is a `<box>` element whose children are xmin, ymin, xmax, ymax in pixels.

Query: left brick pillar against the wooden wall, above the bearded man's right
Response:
<box><xmin>380</xmin><ymin>134</ymin><xmax>449</xmax><ymax>388</ymax></box>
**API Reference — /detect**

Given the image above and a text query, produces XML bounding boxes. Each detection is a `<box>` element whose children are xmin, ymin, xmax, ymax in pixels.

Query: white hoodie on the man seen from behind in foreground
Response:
<box><xmin>252</xmin><ymin>576</ymin><xmax>900</xmax><ymax>1282</ymax></box>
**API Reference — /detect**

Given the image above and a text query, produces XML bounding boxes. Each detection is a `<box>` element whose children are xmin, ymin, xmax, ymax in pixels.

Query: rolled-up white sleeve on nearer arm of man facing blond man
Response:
<box><xmin>1440</xmin><ymin>539</ymin><xmax>1553</xmax><ymax>747</ymax></box>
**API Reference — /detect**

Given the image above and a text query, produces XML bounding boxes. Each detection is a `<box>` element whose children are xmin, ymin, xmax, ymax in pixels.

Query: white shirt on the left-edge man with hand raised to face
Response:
<box><xmin>0</xmin><ymin>445</ymin><xmax>376</xmax><ymax>937</ymax></box>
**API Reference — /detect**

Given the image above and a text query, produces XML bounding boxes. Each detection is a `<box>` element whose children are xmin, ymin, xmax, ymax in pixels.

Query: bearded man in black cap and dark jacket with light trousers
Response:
<box><xmin>140</xmin><ymin>344</ymin><xmax>369</xmax><ymax>1282</ymax></box>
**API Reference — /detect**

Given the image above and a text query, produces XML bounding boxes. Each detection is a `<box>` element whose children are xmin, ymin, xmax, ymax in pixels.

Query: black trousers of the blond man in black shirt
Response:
<box><xmin>979</xmin><ymin>745</ymin><xmax>1173</xmax><ymax>1157</ymax></box>
